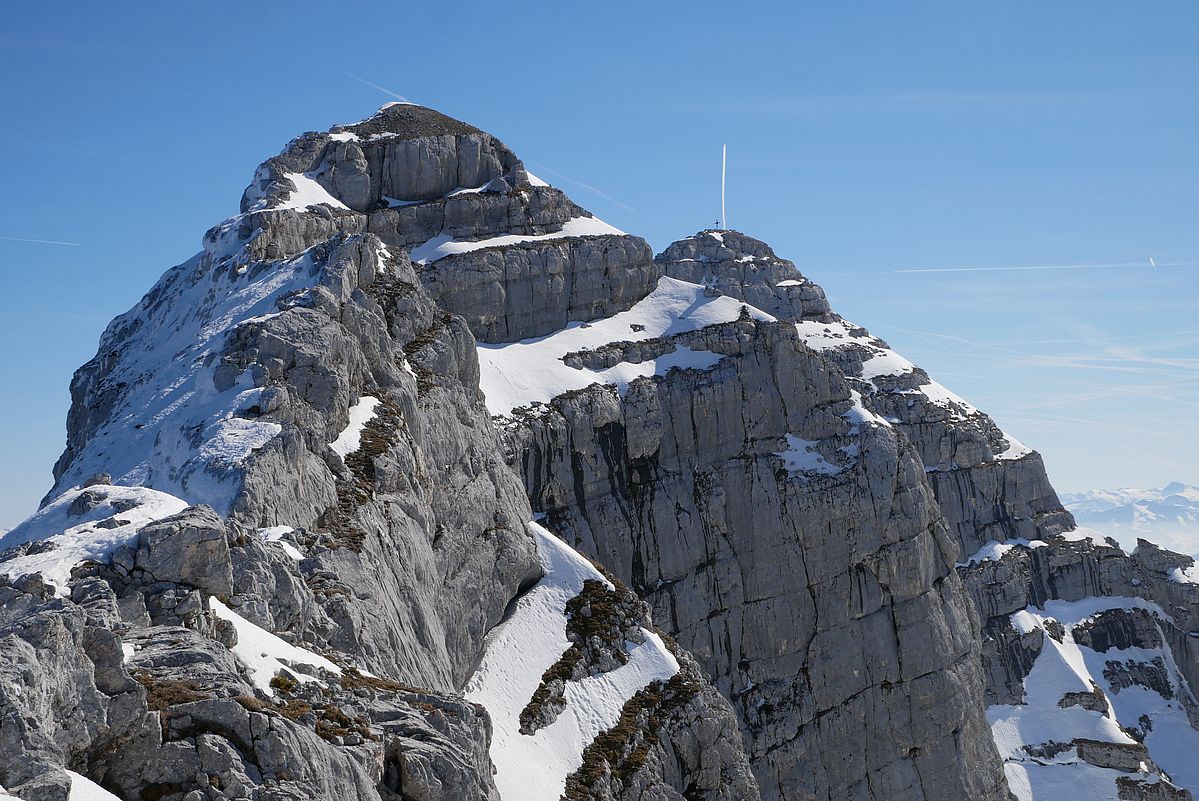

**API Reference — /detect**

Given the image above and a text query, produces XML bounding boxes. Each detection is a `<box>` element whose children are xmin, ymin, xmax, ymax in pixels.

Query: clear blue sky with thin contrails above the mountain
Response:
<box><xmin>0</xmin><ymin>1</ymin><xmax>1199</xmax><ymax>526</ymax></box>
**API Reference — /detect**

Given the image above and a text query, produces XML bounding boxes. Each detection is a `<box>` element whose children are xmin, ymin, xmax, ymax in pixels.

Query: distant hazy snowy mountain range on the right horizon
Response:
<box><xmin>1061</xmin><ymin>481</ymin><xmax>1199</xmax><ymax>555</ymax></box>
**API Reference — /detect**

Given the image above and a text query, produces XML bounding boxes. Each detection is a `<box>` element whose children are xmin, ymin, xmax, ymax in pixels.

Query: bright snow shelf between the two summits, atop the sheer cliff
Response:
<box><xmin>478</xmin><ymin>277</ymin><xmax>775</xmax><ymax>416</ymax></box>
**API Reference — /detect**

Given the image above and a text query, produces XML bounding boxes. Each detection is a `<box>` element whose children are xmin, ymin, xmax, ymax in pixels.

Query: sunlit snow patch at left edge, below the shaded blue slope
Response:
<box><xmin>0</xmin><ymin>484</ymin><xmax>187</xmax><ymax>595</ymax></box>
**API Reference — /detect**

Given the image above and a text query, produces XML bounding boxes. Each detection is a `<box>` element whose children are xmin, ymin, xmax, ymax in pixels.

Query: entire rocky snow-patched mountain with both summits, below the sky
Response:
<box><xmin>0</xmin><ymin>103</ymin><xmax>1199</xmax><ymax>801</ymax></box>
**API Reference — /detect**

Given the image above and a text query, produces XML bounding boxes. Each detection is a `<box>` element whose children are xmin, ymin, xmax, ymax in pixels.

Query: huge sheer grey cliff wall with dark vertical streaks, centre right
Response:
<box><xmin>504</xmin><ymin>320</ymin><xmax>1006</xmax><ymax>799</ymax></box>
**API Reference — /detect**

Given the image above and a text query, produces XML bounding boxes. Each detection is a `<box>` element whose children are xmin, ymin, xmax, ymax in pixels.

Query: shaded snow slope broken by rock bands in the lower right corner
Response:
<box><xmin>987</xmin><ymin>597</ymin><xmax>1199</xmax><ymax>801</ymax></box>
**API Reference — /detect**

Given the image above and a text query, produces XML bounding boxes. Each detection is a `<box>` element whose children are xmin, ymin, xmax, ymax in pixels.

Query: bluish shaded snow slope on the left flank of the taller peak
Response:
<box><xmin>46</xmin><ymin>236</ymin><xmax>376</xmax><ymax>513</ymax></box>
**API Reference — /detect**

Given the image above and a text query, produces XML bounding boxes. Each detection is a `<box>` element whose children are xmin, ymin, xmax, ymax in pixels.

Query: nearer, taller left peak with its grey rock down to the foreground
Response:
<box><xmin>0</xmin><ymin>106</ymin><xmax>757</xmax><ymax>801</ymax></box>
